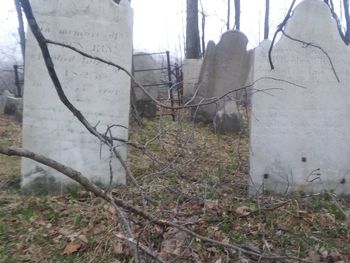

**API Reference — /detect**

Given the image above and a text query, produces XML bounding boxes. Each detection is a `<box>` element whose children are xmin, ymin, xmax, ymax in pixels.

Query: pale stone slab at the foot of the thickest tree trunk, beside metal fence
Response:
<box><xmin>182</xmin><ymin>59</ymin><xmax>203</xmax><ymax>98</ymax></box>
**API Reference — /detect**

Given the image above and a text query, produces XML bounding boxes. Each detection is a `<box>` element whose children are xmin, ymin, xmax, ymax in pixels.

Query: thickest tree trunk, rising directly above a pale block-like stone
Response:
<box><xmin>186</xmin><ymin>0</ymin><xmax>201</xmax><ymax>58</ymax></box>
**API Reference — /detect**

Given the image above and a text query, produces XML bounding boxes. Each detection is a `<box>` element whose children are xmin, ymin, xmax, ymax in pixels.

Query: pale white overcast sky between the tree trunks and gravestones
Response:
<box><xmin>0</xmin><ymin>0</ymin><xmax>332</xmax><ymax>63</ymax></box>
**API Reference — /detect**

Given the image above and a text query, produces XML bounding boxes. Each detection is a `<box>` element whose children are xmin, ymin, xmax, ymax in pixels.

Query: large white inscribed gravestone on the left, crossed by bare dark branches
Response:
<box><xmin>22</xmin><ymin>0</ymin><xmax>133</xmax><ymax>194</ymax></box>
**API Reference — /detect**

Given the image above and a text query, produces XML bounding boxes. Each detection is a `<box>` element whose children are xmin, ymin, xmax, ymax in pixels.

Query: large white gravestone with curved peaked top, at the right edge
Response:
<box><xmin>250</xmin><ymin>0</ymin><xmax>350</xmax><ymax>194</ymax></box>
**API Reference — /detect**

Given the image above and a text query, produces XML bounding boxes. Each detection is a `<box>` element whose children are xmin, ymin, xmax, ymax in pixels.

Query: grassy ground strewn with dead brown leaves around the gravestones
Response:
<box><xmin>0</xmin><ymin>112</ymin><xmax>350</xmax><ymax>263</ymax></box>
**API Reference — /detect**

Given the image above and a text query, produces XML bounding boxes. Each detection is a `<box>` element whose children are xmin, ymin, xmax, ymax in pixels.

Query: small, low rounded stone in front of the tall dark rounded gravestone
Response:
<box><xmin>214</xmin><ymin>100</ymin><xmax>242</xmax><ymax>134</ymax></box>
